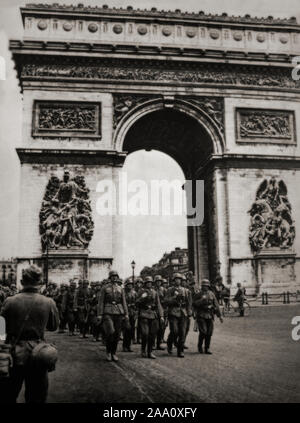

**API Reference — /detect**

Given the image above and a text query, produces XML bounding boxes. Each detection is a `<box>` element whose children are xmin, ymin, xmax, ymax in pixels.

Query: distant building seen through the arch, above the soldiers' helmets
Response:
<box><xmin>141</xmin><ymin>247</ymin><xmax>189</xmax><ymax>279</ymax></box>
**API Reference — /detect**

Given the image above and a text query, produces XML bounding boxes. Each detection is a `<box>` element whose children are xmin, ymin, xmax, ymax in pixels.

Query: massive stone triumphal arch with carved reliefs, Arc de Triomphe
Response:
<box><xmin>10</xmin><ymin>4</ymin><xmax>300</xmax><ymax>293</ymax></box>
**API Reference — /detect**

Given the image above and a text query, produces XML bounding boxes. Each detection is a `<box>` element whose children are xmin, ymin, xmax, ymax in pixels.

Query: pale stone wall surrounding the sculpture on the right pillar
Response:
<box><xmin>228</xmin><ymin>168</ymin><xmax>300</xmax><ymax>292</ymax></box>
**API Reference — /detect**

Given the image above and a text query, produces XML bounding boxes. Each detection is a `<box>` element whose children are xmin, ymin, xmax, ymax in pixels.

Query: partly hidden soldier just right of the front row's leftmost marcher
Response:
<box><xmin>123</xmin><ymin>279</ymin><xmax>137</xmax><ymax>352</ymax></box>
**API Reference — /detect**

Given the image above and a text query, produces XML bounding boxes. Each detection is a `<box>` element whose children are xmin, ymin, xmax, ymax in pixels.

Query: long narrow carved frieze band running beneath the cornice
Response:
<box><xmin>21</xmin><ymin>57</ymin><xmax>300</xmax><ymax>89</ymax></box>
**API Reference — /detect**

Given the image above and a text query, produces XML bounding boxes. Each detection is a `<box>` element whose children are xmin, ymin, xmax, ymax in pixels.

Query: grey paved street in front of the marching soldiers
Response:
<box><xmin>20</xmin><ymin>305</ymin><xmax>300</xmax><ymax>403</ymax></box>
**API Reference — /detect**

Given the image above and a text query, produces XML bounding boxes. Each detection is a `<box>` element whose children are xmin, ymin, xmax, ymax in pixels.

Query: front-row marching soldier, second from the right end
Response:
<box><xmin>166</xmin><ymin>273</ymin><xmax>192</xmax><ymax>357</ymax></box>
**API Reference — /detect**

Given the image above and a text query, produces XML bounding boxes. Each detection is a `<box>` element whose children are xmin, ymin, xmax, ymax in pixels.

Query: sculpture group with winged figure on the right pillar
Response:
<box><xmin>249</xmin><ymin>177</ymin><xmax>295</xmax><ymax>253</ymax></box>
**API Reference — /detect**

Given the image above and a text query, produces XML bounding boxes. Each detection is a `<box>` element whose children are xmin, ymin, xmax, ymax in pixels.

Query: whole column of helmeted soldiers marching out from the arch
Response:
<box><xmin>32</xmin><ymin>270</ymin><xmax>222</xmax><ymax>361</ymax></box>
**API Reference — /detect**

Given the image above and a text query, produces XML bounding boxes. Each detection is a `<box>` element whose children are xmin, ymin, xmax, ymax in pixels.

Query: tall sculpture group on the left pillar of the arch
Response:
<box><xmin>40</xmin><ymin>170</ymin><xmax>94</xmax><ymax>251</ymax></box>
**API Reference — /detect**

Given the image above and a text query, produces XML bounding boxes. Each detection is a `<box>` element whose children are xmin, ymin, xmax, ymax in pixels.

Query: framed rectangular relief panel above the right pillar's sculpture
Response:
<box><xmin>237</xmin><ymin>109</ymin><xmax>295</xmax><ymax>144</ymax></box>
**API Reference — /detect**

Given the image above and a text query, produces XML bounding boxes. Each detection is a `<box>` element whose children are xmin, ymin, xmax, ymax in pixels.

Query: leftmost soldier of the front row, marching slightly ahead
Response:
<box><xmin>97</xmin><ymin>270</ymin><xmax>128</xmax><ymax>361</ymax></box>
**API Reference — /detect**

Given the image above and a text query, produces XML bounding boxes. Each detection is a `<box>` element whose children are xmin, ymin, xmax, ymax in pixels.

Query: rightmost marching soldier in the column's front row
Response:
<box><xmin>193</xmin><ymin>279</ymin><xmax>223</xmax><ymax>354</ymax></box>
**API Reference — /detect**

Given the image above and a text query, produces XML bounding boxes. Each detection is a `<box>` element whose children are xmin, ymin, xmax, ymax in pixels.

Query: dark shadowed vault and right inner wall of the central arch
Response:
<box><xmin>119</xmin><ymin>107</ymin><xmax>218</xmax><ymax>281</ymax></box>
